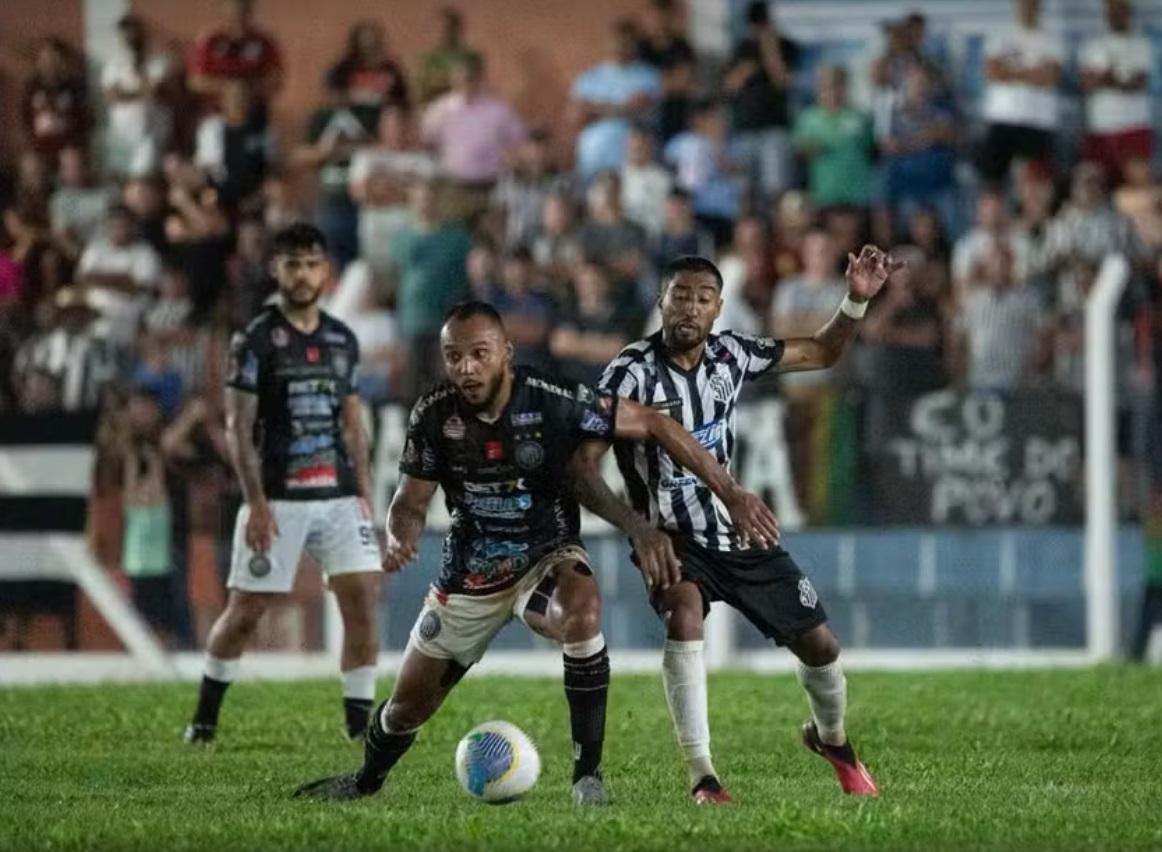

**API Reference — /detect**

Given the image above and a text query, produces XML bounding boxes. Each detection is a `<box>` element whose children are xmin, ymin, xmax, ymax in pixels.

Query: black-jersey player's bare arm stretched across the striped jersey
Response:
<box><xmin>614</xmin><ymin>399</ymin><xmax>779</xmax><ymax>547</ymax></box>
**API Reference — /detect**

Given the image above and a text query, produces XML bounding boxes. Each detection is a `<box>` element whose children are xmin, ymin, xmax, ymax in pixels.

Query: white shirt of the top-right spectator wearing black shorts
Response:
<box><xmin>983</xmin><ymin>27</ymin><xmax>1066</xmax><ymax>130</ymax></box>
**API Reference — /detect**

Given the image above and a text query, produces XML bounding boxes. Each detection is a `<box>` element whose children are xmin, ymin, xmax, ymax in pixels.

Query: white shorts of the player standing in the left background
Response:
<box><xmin>227</xmin><ymin>497</ymin><xmax>381</xmax><ymax>594</ymax></box>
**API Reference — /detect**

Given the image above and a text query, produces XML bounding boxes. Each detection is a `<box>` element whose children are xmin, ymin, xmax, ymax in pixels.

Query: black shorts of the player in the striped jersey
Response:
<box><xmin>634</xmin><ymin>535</ymin><xmax>827</xmax><ymax>645</ymax></box>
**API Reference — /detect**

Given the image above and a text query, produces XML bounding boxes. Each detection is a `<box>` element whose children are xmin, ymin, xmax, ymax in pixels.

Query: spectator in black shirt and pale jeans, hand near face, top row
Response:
<box><xmin>724</xmin><ymin>0</ymin><xmax>799</xmax><ymax>206</ymax></box>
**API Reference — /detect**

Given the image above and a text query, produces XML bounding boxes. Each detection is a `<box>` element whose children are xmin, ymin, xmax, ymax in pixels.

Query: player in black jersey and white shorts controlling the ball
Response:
<box><xmin>297</xmin><ymin>302</ymin><xmax>777</xmax><ymax>804</ymax></box>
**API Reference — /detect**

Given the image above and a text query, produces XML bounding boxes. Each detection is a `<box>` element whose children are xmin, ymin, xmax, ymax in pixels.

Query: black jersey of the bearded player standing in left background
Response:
<box><xmin>227</xmin><ymin>307</ymin><xmax>359</xmax><ymax>500</ymax></box>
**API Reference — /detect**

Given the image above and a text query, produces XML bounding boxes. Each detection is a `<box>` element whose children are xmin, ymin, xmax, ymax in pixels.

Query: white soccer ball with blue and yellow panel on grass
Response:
<box><xmin>456</xmin><ymin>721</ymin><xmax>540</xmax><ymax>804</ymax></box>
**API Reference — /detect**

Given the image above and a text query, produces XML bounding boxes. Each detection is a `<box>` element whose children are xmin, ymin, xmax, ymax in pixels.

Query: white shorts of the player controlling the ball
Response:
<box><xmin>408</xmin><ymin>544</ymin><xmax>589</xmax><ymax>666</ymax></box>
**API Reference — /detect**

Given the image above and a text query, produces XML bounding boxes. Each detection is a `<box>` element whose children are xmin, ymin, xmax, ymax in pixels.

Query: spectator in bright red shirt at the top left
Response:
<box><xmin>188</xmin><ymin>0</ymin><xmax>284</xmax><ymax>127</ymax></box>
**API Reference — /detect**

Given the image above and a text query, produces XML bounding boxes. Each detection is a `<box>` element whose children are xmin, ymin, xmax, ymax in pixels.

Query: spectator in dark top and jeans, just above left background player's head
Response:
<box><xmin>292</xmin><ymin>79</ymin><xmax>379</xmax><ymax>272</ymax></box>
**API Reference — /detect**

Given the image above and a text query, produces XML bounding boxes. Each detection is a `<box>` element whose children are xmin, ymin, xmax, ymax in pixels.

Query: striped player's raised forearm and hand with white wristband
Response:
<box><xmin>775</xmin><ymin>245</ymin><xmax>904</xmax><ymax>373</ymax></box>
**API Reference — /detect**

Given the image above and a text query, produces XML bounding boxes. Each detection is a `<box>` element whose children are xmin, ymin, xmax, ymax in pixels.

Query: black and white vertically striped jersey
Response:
<box><xmin>600</xmin><ymin>331</ymin><xmax>783</xmax><ymax>550</ymax></box>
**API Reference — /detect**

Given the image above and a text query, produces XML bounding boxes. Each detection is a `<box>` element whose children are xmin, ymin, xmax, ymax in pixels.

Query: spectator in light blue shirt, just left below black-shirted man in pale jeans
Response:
<box><xmin>666</xmin><ymin>101</ymin><xmax>739</xmax><ymax>246</ymax></box>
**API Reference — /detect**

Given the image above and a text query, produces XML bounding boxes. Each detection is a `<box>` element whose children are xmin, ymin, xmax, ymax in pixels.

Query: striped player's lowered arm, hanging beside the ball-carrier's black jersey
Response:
<box><xmin>568</xmin><ymin>441</ymin><xmax>682</xmax><ymax>590</ymax></box>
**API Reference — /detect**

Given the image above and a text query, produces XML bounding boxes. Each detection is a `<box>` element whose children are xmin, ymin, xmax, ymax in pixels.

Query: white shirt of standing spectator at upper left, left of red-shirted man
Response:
<box><xmin>101</xmin><ymin>49</ymin><xmax>173</xmax><ymax>174</ymax></box>
